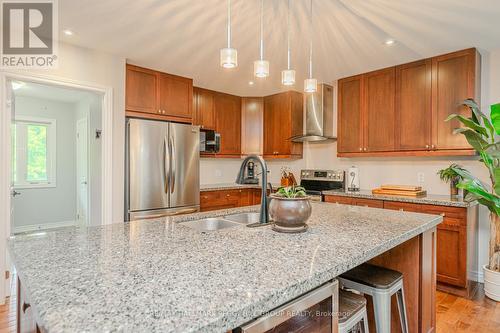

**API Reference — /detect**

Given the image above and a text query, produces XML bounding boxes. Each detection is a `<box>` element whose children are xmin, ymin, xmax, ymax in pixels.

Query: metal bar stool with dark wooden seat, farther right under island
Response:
<box><xmin>339</xmin><ymin>264</ymin><xmax>408</xmax><ymax>333</ymax></box>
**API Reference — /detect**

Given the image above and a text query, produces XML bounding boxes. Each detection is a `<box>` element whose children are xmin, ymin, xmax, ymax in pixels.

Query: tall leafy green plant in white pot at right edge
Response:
<box><xmin>446</xmin><ymin>99</ymin><xmax>500</xmax><ymax>302</ymax></box>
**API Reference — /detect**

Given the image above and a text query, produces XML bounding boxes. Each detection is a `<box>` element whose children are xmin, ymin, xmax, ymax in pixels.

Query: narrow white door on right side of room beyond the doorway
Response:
<box><xmin>76</xmin><ymin>118</ymin><xmax>89</xmax><ymax>225</ymax></box>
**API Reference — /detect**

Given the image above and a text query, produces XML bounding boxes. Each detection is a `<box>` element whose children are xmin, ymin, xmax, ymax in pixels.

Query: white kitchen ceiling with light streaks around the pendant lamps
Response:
<box><xmin>59</xmin><ymin>0</ymin><xmax>500</xmax><ymax>96</ymax></box>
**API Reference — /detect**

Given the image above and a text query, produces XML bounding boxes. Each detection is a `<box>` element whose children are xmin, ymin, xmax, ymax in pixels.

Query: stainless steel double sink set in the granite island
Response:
<box><xmin>180</xmin><ymin>212</ymin><xmax>260</xmax><ymax>232</ymax></box>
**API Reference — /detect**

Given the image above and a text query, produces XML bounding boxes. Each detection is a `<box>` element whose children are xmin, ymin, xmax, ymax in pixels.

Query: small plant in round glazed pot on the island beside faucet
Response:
<box><xmin>269</xmin><ymin>186</ymin><xmax>311</xmax><ymax>233</ymax></box>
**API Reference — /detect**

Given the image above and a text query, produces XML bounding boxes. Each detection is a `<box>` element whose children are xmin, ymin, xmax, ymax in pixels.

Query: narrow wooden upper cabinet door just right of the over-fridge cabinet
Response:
<box><xmin>193</xmin><ymin>87</ymin><xmax>215</xmax><ymax>130</ymax></box>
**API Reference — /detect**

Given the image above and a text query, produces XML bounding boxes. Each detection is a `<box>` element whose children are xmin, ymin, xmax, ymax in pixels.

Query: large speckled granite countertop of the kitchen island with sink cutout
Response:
<box><xmin>8</xmin><ymin>203</ymin><xmax>442</xmax><ymax>332</ymax></box>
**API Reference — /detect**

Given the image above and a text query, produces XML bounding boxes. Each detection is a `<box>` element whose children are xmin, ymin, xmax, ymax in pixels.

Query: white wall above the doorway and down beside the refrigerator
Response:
<box><xmin>11</xmin><ymin>43</ymin><xmax>125</xmax><ymax>222</ymax></box>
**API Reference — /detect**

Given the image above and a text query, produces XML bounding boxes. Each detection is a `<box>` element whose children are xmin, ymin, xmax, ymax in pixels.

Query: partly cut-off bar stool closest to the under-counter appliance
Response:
<box><xmin>339</xmin><ymin>290</ymin><xmax>368</xmax><ymax>333</ymax></box>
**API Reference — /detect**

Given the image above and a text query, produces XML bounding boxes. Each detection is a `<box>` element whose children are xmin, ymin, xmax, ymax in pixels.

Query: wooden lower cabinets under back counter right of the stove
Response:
<box><xmin>325</xmin><ymin>195</ymin><xmax>478</xmax><ymax>297</ymax></box>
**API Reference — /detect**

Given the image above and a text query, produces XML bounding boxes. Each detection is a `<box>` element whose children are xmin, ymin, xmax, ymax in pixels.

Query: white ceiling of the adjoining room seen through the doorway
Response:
<box><xmin>14</xmin><ymin>81</ymin><xmax>97</xmax><ymax>103</ymax></box>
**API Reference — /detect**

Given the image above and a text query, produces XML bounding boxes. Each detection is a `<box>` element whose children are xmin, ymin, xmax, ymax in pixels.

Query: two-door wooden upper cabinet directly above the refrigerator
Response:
<box><xmin>125</xmin><ymin>64</ymin><xmax>193</xmax><ymax>123</ymax></box>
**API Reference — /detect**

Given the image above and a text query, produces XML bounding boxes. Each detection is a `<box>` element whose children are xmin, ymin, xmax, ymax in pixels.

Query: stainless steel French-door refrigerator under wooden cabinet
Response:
<box><xmin>125</xmin><ymin>119</ymin><xmax>200</xmax><ymax>221</ymax></box>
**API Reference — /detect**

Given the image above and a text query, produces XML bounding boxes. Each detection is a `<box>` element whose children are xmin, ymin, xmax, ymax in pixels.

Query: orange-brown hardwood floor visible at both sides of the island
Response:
<box><xmin>0</xmin><ymin>279</ymin><xmax>500</xmax><ymax>333</ymax></box>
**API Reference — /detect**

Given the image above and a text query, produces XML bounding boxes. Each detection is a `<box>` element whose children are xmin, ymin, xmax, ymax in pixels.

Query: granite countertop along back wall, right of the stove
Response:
<box><xmin>323</xmin><ymin>190</ymin><xmax>477</xmax><ymax>207</ymax></box>
